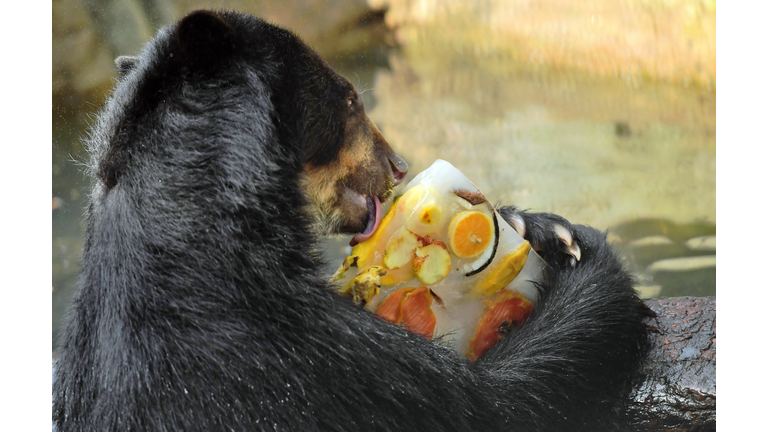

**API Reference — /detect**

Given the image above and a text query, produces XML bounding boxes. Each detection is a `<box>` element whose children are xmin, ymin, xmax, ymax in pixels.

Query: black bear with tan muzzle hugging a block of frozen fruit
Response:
<box><xmin>53</xmin><ymin>11</ymin><xmax>645</xmax><ymax>432</ymax></box>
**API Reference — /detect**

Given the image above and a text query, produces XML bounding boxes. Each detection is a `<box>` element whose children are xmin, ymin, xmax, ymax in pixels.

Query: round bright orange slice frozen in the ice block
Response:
<box><xmin>448</xmin><ymin>211</ymin><xmax>493</xmax><ymax>258</ymax></box>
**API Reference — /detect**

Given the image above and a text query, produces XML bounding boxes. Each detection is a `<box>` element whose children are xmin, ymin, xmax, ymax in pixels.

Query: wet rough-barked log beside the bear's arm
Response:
<box><xmin>627</xmin><ymin>297</ymin><xmax>717</xmax><ymax>432</ymax></box>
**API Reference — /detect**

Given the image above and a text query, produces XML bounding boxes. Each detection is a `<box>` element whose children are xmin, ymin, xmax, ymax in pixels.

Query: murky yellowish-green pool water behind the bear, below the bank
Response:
<box><xmin>52</xmin><ymin>4</ymin><xmax>716</xmax><ymax>352</ymax></box>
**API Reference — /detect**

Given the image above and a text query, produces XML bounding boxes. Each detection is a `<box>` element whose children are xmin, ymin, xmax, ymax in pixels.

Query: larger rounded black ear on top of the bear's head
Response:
<box><xmin>176</xmin><ymin>10</ymin><xmax>232</xmax><ymax>61</ymax></box>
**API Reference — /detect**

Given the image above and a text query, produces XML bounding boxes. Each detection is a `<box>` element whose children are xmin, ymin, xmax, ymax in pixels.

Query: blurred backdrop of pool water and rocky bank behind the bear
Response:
<box><xmin>52</xmin><ymin>0</ymin><xmax>716</xmax><ymax>347</ymax></box>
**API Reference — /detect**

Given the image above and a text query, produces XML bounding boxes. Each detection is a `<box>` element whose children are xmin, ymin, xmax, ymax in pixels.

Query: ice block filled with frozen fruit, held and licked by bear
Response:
<box><xmin>334</xmin><ymin>160</ymin><xmax>545</xmax><ymax>359</ymax></box>
